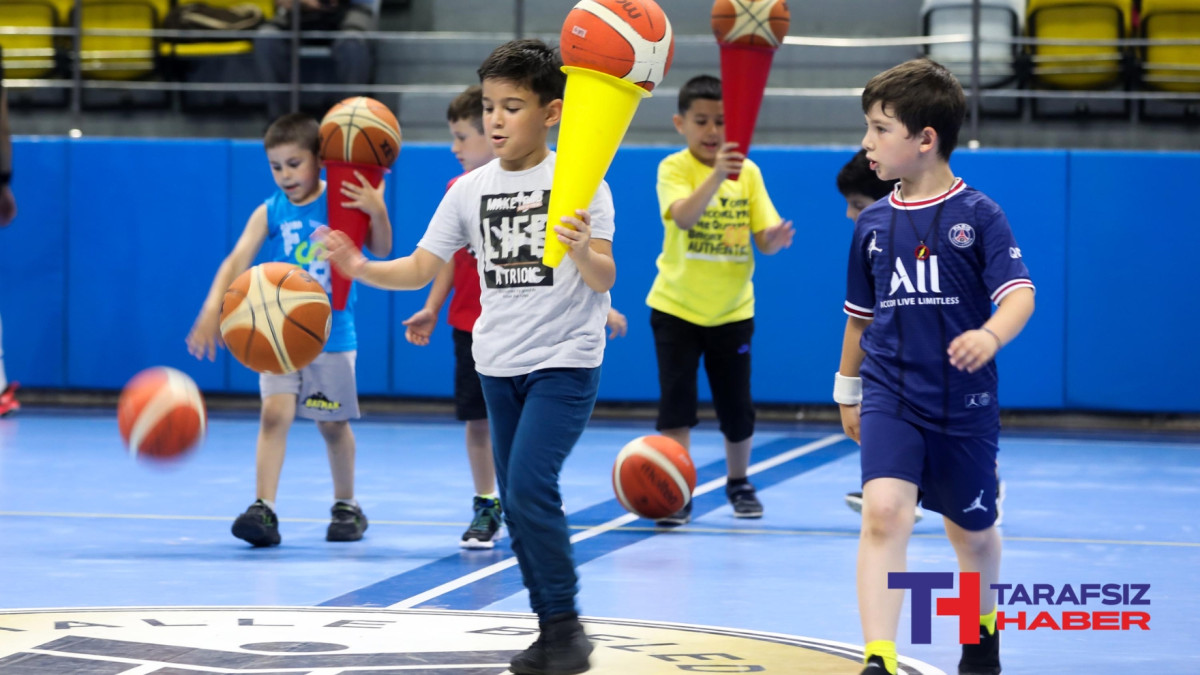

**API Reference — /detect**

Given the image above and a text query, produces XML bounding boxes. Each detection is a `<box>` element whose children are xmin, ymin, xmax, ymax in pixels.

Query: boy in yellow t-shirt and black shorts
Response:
<box><xmin>646</xmin><ymin>76</ymin><xmax>793</xmax><ymax>526</ymax></box>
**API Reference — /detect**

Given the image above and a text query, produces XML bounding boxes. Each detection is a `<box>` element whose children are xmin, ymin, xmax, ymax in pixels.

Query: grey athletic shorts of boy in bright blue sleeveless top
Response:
<box><xmin>258</xmin><ymin>352</ymin><xmax>361</xmax><ymax>422</ymax></box>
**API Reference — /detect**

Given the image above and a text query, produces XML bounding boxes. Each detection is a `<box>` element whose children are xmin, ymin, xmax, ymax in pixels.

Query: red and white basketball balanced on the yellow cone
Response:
<box><xmin>559</xmin><ymin>0</ymin><xmax>674</xmax><ymax>91</ymax></box>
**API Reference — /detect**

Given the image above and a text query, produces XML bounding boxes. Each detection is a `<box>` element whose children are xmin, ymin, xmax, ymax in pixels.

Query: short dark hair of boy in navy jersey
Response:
<box><xmin>863</xmin><ymin>59</ymin><xmax>967</xmax><ymax>160</ymax></box>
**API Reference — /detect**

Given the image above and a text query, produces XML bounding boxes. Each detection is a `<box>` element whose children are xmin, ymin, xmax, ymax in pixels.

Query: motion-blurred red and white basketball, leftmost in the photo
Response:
<box><xmin>116</xmin><ymin>366</ymin><xmax>208</xmax><ymax>460</ymax></box>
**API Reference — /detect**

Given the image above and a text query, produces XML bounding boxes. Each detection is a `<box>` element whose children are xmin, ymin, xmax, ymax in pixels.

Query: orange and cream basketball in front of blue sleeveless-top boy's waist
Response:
<box><xmin>221</xmin><ymin>263</ymin><xmax>332</xmax><ymax>375</ymax></box>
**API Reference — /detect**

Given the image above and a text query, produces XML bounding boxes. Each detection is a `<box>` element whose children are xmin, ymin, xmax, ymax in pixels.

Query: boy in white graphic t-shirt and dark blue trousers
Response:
<box><xmin>325</xmin><ymin>40</ymin><xmax>617</xmax><ymax>675</ymax></box>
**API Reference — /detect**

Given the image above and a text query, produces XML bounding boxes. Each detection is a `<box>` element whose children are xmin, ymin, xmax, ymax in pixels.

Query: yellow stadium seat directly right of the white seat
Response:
<box><xmin>1026</xmin><ymin>0</ymin><xmax>1133</xmax><ymax>89</ymax></box>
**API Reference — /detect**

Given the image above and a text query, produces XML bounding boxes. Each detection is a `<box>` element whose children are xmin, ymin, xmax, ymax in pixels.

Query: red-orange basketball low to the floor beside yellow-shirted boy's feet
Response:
<box><xmin>612</xmin><ymin>436</ymin><xmax>696</xmax><ymax>520</ymax></box>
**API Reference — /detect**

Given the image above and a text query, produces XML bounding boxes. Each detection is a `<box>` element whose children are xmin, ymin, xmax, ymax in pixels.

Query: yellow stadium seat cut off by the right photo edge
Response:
<box><xmin>1141</xmin><ymin>0</ymin><xmax>1200</xmax><ymax>91</ymax></box>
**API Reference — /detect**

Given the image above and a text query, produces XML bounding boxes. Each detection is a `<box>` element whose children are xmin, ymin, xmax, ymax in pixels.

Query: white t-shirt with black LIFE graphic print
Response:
<box><xmin>418</xmin><ymin>153</ymin><xmax>614</xmax><ymax>377</ymax></box>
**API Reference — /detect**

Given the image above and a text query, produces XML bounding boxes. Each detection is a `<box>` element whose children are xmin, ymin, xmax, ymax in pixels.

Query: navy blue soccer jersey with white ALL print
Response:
<box><xmin>845</xmin><ymin>179</ymin><xmax>1033</xmax><ymax>436</ymax></box>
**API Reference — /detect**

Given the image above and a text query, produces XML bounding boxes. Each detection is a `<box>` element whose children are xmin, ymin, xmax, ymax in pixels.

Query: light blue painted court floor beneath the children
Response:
<box><xmin>0</xmin><ymin>408</ymin><xmax>1200</xmax><ymax>675</ymax></box>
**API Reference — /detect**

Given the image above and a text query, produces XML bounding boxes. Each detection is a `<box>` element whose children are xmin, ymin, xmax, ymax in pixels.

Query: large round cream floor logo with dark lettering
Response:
<box><xmin>0</xmin><ymin>608</ymin><xmax>944</xmax><ymax>675</ymax></box>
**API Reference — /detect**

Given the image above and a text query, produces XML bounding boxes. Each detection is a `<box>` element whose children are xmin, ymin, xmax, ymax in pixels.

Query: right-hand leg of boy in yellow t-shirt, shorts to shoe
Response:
<box><xmin>704</xmin><ymin>318</ymin><xmax>762</xmax><ymax>518</ymax></box>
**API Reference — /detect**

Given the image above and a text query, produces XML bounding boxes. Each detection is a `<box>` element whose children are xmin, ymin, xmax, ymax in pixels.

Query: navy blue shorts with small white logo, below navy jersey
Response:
<box><xmin>860</xmin><ymin>412</ymin><xmax>1000</xmax><ymax>531</ymax></box>
